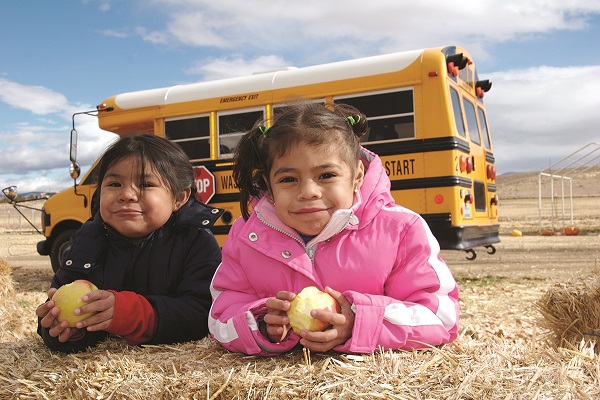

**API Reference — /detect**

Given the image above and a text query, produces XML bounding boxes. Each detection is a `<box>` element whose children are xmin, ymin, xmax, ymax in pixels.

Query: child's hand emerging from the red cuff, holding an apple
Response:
<box><xmin>75</xmin><ymin>290</ymin><xmax>115</xmax><ymax>332</ymax></box>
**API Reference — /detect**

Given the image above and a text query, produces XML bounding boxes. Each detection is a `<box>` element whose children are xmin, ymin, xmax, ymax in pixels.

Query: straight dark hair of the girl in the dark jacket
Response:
<box><xmin>95</xmin><ymin>133</ymin><xmax>196</xmax><ymax>203</ymax></box>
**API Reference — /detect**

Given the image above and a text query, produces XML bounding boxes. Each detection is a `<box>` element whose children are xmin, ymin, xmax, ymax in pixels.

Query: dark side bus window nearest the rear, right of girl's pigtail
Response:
<box><xmin>335</xmin><ymin>89</ymin><xmax>415</xmax><ymax>142</ymax></box>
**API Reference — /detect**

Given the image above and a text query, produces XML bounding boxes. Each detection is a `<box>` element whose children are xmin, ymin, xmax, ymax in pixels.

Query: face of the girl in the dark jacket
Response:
<box><xmin>100</xmin><ymin>157</ymin><xmax>187</xmax><ymax>238</ymax></box>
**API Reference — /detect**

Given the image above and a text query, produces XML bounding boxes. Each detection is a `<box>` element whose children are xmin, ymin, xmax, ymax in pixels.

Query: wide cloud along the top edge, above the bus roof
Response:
<box><xmin>140</xmin><ymin>0</ymin><xmax>600</xmax><ymax>65</ymax></box>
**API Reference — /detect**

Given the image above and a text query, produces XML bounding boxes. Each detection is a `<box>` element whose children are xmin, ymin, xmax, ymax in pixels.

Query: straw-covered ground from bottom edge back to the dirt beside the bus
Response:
<box><xmin>0</xmin><ymin>236</ymin><xmax>600</xmax><ymax>399</ymax></box>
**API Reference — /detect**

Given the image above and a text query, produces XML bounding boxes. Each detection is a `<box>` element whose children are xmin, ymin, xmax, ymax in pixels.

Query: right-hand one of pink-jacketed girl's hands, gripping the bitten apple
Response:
<box><xmin>300</xmin><ymin>287</ymin><xmax>354</xmax><ymax>352</ymax></box>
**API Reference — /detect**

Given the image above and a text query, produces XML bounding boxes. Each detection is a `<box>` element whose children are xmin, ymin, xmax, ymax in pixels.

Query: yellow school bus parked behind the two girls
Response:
<box><xmin>36</xmin><ymin>46</ymin><xmax>500</xmax><ymax>272</ymax></box>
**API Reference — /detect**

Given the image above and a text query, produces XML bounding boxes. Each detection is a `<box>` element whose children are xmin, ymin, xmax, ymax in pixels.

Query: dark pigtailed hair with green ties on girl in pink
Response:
<box><xmin>233</xmin><ymin>100</ymin><xmax>368</xmax><ymax>219</ymax></box>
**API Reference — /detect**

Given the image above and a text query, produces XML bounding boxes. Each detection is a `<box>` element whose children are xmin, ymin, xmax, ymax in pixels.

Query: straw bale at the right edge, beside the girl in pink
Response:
<box><xmin>537</xmin><ymin>269</ymin><xmax>600</xmax><ymax>354</ymax></box>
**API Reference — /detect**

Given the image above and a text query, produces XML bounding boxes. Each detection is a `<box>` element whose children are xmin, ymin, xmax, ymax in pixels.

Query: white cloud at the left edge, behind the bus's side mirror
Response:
<box><xmin>0</xmin><ymin>79</ymin><xmax>116</xmax><ymax>193</ymax></box>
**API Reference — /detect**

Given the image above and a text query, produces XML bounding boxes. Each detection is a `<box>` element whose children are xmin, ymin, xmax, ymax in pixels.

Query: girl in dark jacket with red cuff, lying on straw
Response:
<box><xmin>36</xmin><ymin>134</ymin><xmax>222</xmax><ymax>352</ymax></box>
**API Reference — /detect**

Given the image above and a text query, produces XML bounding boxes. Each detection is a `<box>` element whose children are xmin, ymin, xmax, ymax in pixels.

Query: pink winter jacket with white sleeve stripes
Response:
<box><xmin>209</xmin><ymin>150</ymin><xmax>459</xmax><ymax>356</ymax></box>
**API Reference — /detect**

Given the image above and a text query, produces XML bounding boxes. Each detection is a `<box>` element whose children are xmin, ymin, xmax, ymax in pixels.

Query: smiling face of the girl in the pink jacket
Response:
<box><xmin>269</xmin><ymin>144</ymin><xmax>364</xmax><ymax>235</ymax></box>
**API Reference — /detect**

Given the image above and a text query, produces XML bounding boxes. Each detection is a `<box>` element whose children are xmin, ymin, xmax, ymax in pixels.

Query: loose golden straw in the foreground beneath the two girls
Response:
<box><xmin>0</xmin><ymin>258</ymin><xmax>600</xmax><ymax>400</ymax></box>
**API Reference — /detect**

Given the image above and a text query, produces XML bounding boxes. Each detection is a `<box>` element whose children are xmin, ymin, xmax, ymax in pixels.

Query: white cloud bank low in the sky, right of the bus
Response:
<box><xmin>485</xmin><ymin>66</ymin><xmax>600</xmax><ymax>173</ymax></box>
